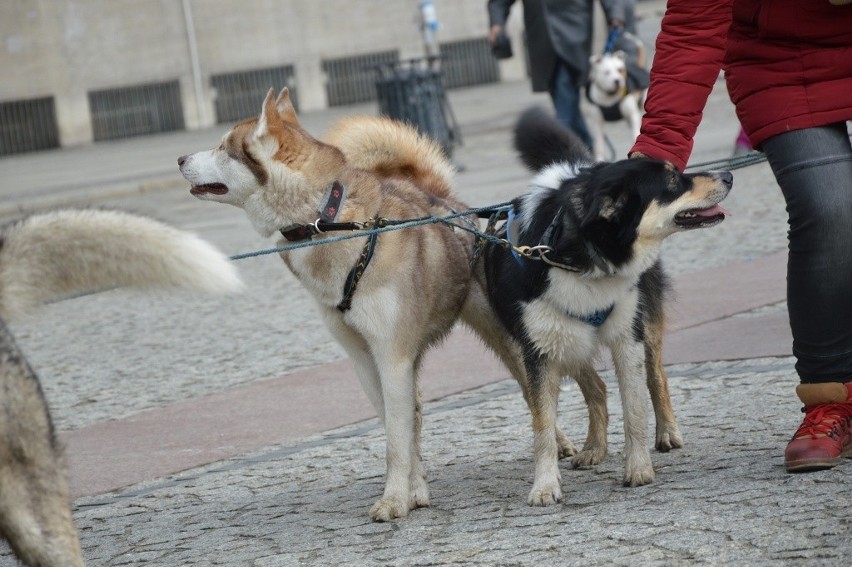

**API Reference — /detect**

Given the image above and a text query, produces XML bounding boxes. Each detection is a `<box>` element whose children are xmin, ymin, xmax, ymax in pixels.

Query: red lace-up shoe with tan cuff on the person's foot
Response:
<box><xmin>784</xmin><ymin>382</ymin><xmax>852</xmax><ymax>472</ymax></box>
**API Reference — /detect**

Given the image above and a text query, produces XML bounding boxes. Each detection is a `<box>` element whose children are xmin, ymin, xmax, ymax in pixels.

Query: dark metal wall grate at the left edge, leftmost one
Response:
<box><xmin>0</xmin><ymin>97</ymin><xmax>59</xmax><ymax>156</ymax></box>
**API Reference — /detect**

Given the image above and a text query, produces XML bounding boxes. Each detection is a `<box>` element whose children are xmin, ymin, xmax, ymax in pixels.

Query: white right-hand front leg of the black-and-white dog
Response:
<box><xmin>610</xmin><ymin>337</ymin><xmax>654</xmax><ymax>486</ymax></box>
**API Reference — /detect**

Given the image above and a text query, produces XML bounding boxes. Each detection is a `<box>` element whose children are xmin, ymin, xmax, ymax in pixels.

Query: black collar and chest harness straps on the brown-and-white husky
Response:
<box><xmin>280</xmin><ymin>181</ymin><xmax>379</xmax><ymax>312</ymax></box>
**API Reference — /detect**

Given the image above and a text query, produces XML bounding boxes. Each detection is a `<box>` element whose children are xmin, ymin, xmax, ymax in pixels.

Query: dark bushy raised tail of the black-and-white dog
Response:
<box><xmin>515</xmin><ymin>107</ymin><xmax>592</xmax><ymax>171</ymax></box>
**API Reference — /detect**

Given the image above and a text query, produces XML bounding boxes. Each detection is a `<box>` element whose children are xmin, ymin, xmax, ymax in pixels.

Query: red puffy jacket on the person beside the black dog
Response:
<box><xmin>630</xmin><ymin>0</ymin><xmax>852</xmax><ymax>169</ymax></box>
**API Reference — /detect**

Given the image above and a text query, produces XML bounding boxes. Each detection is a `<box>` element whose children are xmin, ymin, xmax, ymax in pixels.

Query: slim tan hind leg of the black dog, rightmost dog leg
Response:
<box><xmin>645</xmin><ymin>317</ymin><xmax>683</xmax><ymax>452</ymax></box>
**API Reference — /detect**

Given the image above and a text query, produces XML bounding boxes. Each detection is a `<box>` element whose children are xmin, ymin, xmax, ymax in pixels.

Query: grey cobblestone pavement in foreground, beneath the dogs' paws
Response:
<box><xmin>51</xmin><ymin>358</ymin><xmax>852</xmax><ymax>566</ymax></box>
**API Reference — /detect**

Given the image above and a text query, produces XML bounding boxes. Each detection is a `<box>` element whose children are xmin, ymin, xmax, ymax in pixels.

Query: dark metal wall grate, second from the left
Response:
<box><xmin>89</xmin><ymin>81</ymin><xmax>184</xmax><ymax>142</ymax></box>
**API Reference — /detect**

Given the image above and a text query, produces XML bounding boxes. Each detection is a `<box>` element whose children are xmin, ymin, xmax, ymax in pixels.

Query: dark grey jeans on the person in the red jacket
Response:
<box><xmin>762</xmin><ymin>123</ymin><xmax>852</xmax><ymax>383</ymax></box>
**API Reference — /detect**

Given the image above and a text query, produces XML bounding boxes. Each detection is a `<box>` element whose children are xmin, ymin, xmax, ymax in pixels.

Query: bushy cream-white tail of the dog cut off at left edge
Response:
<box><xmin>0</xmin><ymin>210</ymin><xmax>242</xmax><ymax>317</ymax></box>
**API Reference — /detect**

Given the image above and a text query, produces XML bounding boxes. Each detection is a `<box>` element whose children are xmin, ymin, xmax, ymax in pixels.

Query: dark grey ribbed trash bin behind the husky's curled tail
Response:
<box><xmin>375</xmin><ymin>58</ymin><xmax>459</xmax><ymax>158</ymax></box>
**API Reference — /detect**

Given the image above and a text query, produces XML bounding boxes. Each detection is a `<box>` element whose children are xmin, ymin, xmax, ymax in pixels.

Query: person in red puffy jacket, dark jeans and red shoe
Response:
<box><xmin>629</xmin><ymin>0</ymin><xmax>852</xmax><ymax>472</ymax></box>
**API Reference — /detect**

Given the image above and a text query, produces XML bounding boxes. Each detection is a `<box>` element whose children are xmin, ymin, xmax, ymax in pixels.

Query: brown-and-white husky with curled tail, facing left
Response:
<box><xmin>178</xmin><ymin>89</ymin><xmax>496</xmax><ymax>521</ymax></box>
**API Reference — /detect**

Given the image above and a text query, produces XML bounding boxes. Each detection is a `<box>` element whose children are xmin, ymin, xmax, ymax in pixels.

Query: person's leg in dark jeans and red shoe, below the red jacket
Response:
<box><xmin>763</xmin><ymin>123</ymin><xmax>852</xmax><ymax>471</ymax></box>
